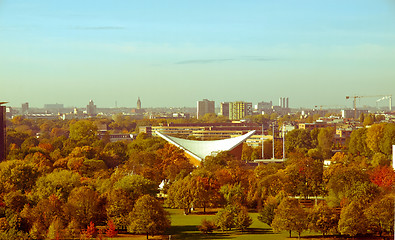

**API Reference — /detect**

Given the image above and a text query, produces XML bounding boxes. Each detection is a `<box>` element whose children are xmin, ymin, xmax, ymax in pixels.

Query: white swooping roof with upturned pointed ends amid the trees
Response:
<box><xmin>155</xmin><ymin>130</ymin><xmax>255</xmax><ymax>161</ymax></box>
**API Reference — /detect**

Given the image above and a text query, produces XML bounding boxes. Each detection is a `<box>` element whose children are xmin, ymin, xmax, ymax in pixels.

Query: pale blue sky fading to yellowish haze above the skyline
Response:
<box><xmin>0</xmin><ymin>0</ymin><xmax>395</xmax><ymax>108</ymax></box>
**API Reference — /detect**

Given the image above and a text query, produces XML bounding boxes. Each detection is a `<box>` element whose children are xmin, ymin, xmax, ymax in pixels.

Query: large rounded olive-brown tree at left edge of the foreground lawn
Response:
<box><xmin>128</xmin><ymin>195</ymin><xmax>170</xmax><ymax>239</ymax></box>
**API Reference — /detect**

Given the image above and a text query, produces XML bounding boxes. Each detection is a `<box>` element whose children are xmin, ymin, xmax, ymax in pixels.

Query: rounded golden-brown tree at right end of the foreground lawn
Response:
<box><xmin>272</xmin><ymin>198</ymin><xmax>307</xmax><ymax>237</ymax></box>
